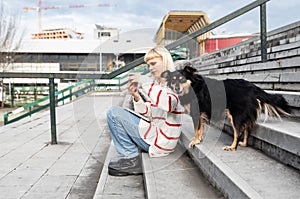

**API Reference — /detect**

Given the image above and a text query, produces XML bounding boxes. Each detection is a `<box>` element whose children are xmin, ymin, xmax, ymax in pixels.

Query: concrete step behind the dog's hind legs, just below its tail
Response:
<box><xmin>224</xmin><ymin>116</ymin><xmax>300</xmax><ymax>171</ymax></box>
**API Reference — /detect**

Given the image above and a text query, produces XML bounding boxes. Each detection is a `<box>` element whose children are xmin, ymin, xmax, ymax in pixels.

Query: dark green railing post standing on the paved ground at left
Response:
<box><xmin>49</xmin><ymin>78</ymin><xmax>57</xmax><ymax>144</ymax></box>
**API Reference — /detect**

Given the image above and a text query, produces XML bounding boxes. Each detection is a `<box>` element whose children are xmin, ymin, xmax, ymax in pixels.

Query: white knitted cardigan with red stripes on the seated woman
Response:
<box><xmin>133</xmin><ymin>82</ymin><xmax>184</xmax><ymax>157</ymax></box>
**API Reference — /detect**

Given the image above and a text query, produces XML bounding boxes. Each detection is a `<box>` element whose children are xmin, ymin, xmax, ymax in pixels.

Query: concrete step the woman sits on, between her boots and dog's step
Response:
<box><xmin>142</xmin><ymin>144</ymin><xmax>223</xmax><ymax>199</ymax></box>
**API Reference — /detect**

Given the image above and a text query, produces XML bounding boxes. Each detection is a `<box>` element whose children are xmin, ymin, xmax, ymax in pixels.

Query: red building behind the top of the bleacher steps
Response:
<box><xmin>204</xmin><ymin>35</ymin><xmax>254</xmax><ymax>53</ymax></box>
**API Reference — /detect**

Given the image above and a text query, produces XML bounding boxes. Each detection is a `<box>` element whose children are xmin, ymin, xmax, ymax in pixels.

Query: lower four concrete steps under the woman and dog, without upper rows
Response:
<box><xmin>94</xmin><ymin>96</ymin><xmax>300</xmax><ymax>199</ymax></box>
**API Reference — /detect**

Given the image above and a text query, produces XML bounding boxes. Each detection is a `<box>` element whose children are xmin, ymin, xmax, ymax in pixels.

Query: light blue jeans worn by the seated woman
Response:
<box><xmin>106</xmin><ymin>106</ymin><xmax>149</xmax><ymax>158</ymax></box>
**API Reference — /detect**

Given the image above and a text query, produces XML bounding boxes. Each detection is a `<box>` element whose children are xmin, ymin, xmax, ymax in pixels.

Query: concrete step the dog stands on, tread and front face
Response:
<box><xmin>181</xmin><ymin>114</ymin><xmax>300</xmax><ymax>198</ymax></box>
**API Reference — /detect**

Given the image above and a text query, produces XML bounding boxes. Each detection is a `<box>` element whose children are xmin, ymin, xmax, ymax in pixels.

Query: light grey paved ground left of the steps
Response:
<box><xmin>0</xmin><ymin>95</ymin><xmax>123</xmax><ymax>199</ymax></box>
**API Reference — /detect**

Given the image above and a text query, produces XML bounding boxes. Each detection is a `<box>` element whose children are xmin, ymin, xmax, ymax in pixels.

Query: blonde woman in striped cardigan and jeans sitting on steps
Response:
<box><xmin>107</xmin><ymin>47</ymin><xmax>184</xmax><ymax>176</ymax></box>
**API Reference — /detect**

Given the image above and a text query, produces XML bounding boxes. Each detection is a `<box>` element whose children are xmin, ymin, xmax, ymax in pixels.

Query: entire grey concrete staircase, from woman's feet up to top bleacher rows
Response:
<box><xmin>94</xmin><ymin>22</ymin><xmax>300</xmax><ymax>199</ymax></box>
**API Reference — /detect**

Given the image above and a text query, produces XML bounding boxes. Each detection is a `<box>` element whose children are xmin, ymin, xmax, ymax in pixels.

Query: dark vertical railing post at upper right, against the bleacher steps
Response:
<box><xmin>260</xmin><ymin>3</ymin><xmax>268</xmax><ymax>62</ymax></box>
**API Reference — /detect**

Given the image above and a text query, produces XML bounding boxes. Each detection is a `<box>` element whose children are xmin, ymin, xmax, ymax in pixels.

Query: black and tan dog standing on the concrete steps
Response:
<box><xmin>162</xmin><ymin>64</ymin><xmax>290</xmax><ymax>151</ymax></box>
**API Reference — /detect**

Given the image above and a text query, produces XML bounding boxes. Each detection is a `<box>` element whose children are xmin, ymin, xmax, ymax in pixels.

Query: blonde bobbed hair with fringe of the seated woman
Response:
<box><xmin>144</xmin><ymin>46</ymin><xmax>175</xmax><ymax>71</ymax></box>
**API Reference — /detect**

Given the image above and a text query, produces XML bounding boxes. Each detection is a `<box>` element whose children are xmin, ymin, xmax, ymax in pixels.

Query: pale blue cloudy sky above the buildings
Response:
<box><xmin>0</xmin><ymin>0</ymin><xmax>300</xmax><ymax>39</ymax></box>
